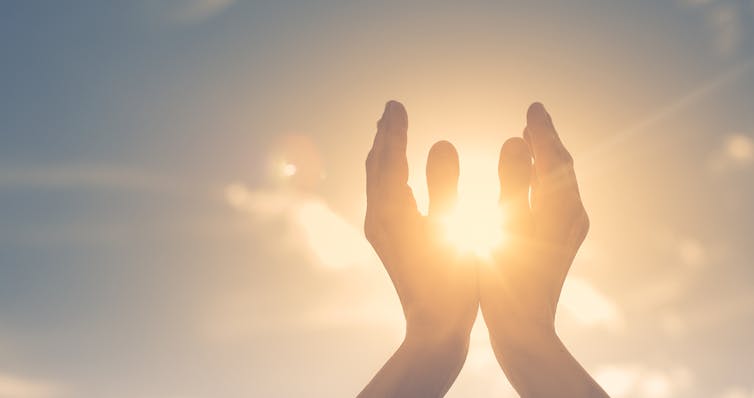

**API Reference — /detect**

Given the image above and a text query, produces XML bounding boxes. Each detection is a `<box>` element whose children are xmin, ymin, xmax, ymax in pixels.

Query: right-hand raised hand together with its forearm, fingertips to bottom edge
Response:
<box><xmin>479</xmin><ymin>103</ymin><xmax>606</xmax><ymax>397</ymax></box>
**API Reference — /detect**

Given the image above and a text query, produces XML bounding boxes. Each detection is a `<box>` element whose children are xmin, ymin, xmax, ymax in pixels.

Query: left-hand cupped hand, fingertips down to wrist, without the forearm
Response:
<box><xmin>364</xmin><ymin>101</ymin><xmax>478</xmax><ymax>342</ymax></box>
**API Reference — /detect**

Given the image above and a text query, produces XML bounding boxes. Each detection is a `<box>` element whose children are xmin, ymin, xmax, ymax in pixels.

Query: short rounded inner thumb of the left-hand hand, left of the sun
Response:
<box><xmin>427</xmin><ymin>141</ymin><xmax>459</xmax><ymax>218</ymax></box>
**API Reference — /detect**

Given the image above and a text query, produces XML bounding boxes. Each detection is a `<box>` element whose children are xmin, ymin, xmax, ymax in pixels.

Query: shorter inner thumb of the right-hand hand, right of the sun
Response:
<box><xmin>498</xmin><ymin>137</ymin><xmax>532</xmax><ymax>236</ymax></box>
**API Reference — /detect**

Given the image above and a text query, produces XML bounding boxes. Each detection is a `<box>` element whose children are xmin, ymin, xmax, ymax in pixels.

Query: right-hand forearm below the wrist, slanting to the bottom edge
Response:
<box><xmin>490</xmin><ymin>328</ymin><xmax>607</xmax><ymax>398</ymax></box>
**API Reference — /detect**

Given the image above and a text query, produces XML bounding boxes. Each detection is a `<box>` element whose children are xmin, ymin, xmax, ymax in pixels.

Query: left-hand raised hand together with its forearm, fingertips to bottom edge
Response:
<box><xmin>360</xmin><ymin>101</ymin><xmax>479</xmax><ymax>397</ymax></box>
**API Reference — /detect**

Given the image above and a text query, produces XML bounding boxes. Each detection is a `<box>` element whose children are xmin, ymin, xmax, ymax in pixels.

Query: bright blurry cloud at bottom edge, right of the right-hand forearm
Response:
<box><xmin>594</xmin><ymin>364</ymin><xmax>693</xmax><ymax>398</ymax></box>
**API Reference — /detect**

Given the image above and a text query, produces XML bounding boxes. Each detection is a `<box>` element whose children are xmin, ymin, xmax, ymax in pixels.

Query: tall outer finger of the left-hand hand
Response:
<box><xmin>377</xmin><ymin>101</ymin><xmax>418</xmax><ymax>222</ymax></box>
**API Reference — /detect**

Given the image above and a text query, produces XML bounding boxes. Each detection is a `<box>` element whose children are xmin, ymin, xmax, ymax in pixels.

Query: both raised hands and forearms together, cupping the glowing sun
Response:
<box><xmin>359</xmin><ymin>101</ymin><xmax>607</xmax><ymax>398</ymax></box>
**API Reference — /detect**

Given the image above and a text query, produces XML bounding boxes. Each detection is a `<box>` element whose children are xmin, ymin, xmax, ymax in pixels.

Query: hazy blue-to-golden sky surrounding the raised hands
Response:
<box><xmin>0</xmin><ymin>0</ymin><xmax>754</xmax><ymax>398</ymax></box>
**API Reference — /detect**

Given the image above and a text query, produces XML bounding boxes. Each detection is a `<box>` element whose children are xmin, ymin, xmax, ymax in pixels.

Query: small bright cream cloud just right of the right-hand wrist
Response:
<box><xmin>558</xmin><ymin>276</ymin><xmax>625</xmax><ymax>330</ymax></box>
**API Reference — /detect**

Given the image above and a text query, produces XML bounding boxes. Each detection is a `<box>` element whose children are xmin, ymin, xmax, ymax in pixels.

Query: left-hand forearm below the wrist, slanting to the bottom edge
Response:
<box><xmin>358</xmin><ymin>326</ymin><xmax>469</xmax><ymax>398</ymax></box>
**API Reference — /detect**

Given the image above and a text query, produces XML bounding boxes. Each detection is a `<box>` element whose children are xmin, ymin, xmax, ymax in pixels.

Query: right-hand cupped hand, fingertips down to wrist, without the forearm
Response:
<box><xmin>479</xmin><ymin>103</ymin><xmax>589</xmax><ymax>354</ymax></box>
